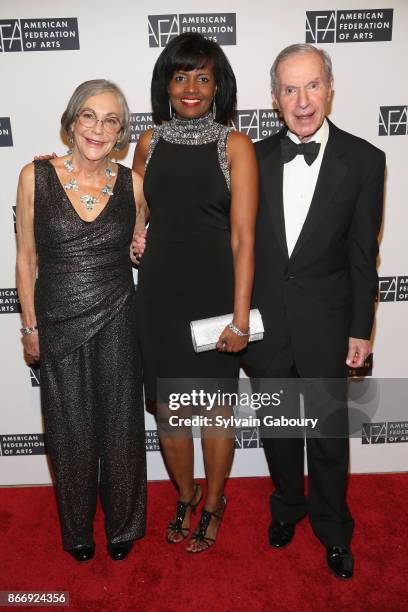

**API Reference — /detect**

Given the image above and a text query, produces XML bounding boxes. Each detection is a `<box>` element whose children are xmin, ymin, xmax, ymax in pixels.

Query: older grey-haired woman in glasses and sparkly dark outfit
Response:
<box><xmin>17</xmin><ymin>80</ymin><xmax>146</xmax><ymax>561</ymax></box>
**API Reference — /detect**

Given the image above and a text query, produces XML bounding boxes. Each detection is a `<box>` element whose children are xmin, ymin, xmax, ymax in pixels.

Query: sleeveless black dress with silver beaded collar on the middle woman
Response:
<box><xmin>137</xmin><ymin>116</ymin><xmax>239</xmax><ymax>401</ymax></box>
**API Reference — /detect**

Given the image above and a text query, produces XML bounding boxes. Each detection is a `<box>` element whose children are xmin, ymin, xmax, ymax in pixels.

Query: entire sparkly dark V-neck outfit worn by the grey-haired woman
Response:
<box><xmin>34</xmin><ymin>160</ymin><xmax>146</xmax><ymax>550</ymax></box>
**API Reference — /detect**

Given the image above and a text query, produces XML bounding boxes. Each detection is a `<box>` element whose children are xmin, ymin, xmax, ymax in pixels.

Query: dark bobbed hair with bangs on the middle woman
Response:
<box><xmin>151</xmin><ymin>32</ymin><xmax>237</xmax><ymax>125</ymax></box>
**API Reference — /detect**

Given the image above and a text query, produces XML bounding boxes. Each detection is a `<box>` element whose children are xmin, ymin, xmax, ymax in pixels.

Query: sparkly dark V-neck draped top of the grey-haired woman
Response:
<box><xmin>34</xmin><ymin>160</ymin><xmax>136</xmax><ymax>359</ymax></box>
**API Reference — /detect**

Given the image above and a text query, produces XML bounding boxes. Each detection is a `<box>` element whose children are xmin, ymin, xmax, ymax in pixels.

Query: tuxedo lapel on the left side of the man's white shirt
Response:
<box><xmin>259</xmin><ymin>139</ymin><xmax>289</xmax><ymax>258</ymax></box>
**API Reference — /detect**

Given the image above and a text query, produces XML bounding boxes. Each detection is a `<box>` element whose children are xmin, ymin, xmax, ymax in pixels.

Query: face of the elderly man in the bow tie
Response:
<box><xmin>273</xmin><ymin>53</ymin><xmax>332</xmax><ymax>142</ymax></box>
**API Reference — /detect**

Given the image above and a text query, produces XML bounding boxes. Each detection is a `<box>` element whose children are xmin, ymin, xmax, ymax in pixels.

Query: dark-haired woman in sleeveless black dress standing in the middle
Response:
<box><xmin>133</xmin><ymin>34</ymin><xmax>257</xmax><ymax>552</ymax></box>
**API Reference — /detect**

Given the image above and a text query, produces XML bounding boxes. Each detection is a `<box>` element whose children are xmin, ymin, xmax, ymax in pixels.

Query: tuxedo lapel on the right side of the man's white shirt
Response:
<box><xmin>291</xmin><ymin>123</ymin><xmax>347</xmax><ymax>259</ymax></box>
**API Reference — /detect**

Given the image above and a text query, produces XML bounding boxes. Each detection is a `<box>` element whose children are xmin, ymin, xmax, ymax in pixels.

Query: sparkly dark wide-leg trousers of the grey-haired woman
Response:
<box><xmin>41</xmin><ymin>299</ymin><xmax>146</xmax><ymax>550</ymax></box>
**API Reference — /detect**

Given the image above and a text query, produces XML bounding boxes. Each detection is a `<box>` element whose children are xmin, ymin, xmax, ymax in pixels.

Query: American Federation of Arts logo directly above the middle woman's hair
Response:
<box><xmin>147</xmin><ymin>13</ymin><xmax>237</xmax><ymax>47</ymax></box>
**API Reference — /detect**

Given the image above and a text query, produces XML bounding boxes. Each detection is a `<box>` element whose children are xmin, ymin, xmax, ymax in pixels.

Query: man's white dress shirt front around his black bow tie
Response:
<box><xmin>283</xmin><ymin>119</ymin><xmax>329</xmax><ymax>256</ymax></box>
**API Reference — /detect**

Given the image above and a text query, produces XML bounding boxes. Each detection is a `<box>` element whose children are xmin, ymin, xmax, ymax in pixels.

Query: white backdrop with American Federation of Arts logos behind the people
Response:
<box><xmin>0</xmin><ymin>0</ymin><xmax>408</xmax><ymax>485</ymax></box>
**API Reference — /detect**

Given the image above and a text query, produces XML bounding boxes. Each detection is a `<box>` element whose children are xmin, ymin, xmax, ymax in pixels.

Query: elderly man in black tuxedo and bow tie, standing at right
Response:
<box><xmin>246</xmin><ymin>44</ymin><xmax>385</xmax><ymax>579</ymax></box>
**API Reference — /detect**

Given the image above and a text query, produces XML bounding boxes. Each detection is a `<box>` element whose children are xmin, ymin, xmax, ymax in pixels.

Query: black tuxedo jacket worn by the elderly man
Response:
<box><xmin>246</xmin><ymin>121</ymin><xmax>385</xmax><ymax>377</ymax></box>
